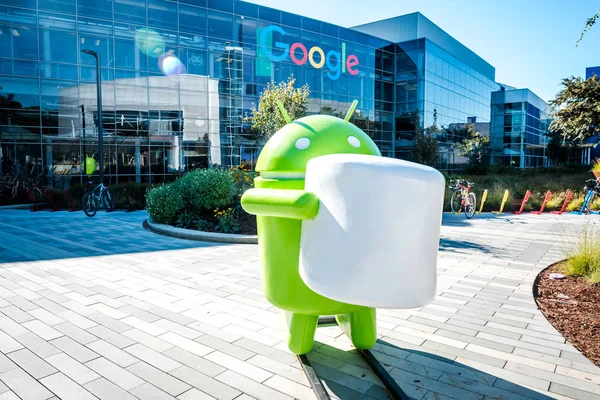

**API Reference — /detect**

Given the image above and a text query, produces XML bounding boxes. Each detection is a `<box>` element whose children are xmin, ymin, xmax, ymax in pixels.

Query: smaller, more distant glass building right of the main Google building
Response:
<box><xmin>490</xmin><ymin>89</ymin><xmax>550</xmax><ymax>168</ymax></box>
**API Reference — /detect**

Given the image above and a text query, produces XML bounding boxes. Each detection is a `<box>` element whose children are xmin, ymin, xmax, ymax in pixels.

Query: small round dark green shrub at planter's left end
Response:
<box><xmin>146</xmin><ymin>183</ymin><xmax>185</xmax><ymax>224</ymax></box>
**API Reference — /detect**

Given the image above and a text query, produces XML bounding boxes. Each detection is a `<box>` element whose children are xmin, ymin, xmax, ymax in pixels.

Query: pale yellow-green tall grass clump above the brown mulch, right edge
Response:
<box><xmin>562</xmin><ymin>224</ymin><xmax>600</xmax><ymax>283</ymax></box>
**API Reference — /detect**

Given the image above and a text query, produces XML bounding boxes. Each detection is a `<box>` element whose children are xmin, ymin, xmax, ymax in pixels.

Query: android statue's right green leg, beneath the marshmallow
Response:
<box><xmin>336</xmin><ymin>308</ymin><xmax>377</xmax><ymax>350</ymax></box>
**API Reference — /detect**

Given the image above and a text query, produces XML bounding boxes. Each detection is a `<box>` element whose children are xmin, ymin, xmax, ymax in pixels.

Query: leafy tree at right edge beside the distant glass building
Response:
<box><xmin>548</xmin><ymin>75</ymin><xmax>600</xmax><ymax>141</ymax></box>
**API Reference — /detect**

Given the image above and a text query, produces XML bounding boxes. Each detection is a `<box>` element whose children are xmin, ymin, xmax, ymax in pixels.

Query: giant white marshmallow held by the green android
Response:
<box><xmin>300</xmin><ymin>154</ymin><xmax>445</xmax><ymax>308</ymax></box>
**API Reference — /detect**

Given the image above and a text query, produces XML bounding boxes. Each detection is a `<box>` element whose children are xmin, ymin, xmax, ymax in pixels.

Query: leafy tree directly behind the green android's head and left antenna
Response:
<box><xmin>244</xmin><ymin>77</ymin><xmax>310</xmax><ymax>137</ymax></box>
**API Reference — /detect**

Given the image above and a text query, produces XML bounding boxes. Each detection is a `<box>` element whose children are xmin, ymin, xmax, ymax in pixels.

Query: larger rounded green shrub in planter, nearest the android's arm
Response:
<box><xmin>175</xmin><ymin>169</ymin><xmax>236</xmax><ymax>216</ymax></box>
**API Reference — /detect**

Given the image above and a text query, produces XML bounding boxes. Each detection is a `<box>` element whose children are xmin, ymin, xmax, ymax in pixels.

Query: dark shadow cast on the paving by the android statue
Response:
<box><xmin>307</xmin><ymin>340</ymin><xmax>553</xmax><ymax>400</ymax></box>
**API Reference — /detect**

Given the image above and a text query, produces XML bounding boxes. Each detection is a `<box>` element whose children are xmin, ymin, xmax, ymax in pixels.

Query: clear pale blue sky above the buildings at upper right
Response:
<box><xmin>248</xmin><ymin>0</ymin><xmax>600</xmax><ymax>101</ymax></box>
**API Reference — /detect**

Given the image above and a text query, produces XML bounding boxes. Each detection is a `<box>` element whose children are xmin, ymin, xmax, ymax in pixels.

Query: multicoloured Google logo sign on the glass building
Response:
<box><xmin>260</xmin><ymin>25</ymin><xmax>358</xmax><ymax>80</ymax></box>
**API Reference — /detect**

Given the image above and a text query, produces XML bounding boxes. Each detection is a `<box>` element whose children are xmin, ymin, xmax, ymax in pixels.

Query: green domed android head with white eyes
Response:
<box><xmin>256</xmin><ymin>104</ymin><xmax>381</xmax><ymax>179</ymax></box>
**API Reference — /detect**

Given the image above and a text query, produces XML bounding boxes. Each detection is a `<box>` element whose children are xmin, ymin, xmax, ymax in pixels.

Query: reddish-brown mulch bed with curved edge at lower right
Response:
<box><xmin>534</xmin><ymin>264</ymin><xmax>600</xmax><ymax>366</ymax></box>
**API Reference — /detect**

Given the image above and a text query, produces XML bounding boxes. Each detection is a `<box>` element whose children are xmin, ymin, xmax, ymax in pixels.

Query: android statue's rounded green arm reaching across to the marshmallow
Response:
<box><xmin>242</xmin><ymin>189</ymin><xmax>319</xmax><ymax>220</ymax></box>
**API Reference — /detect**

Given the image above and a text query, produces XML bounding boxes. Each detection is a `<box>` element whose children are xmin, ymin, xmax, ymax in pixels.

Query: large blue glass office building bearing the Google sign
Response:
<box><xmin>0</xmin><ymin>0</ymin><xmax>498</xmax><ymax>186</ymax></box>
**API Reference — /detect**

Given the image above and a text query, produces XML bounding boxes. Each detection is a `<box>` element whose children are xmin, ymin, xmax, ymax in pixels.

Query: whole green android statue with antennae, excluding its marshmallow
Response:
<box><xmin>242</xmin><ymin>101</ymin><xmax>381</xmax><ymax>354</ymax></box>
